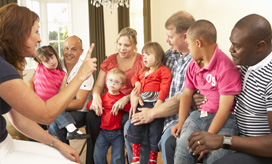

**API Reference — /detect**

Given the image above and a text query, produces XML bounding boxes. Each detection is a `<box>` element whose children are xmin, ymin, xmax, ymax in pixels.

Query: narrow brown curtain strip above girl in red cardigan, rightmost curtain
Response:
<box><xmin>143</xmin><ymin>0</ymin><xmax>151</xmax><ymax>43</ymax></box>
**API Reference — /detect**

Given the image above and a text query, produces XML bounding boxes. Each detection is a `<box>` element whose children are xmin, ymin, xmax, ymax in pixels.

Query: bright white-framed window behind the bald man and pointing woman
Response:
<box><xmin>18</xmin><ymin>0</ymin><xmax>71</xmax><ymax>69</ymax></box>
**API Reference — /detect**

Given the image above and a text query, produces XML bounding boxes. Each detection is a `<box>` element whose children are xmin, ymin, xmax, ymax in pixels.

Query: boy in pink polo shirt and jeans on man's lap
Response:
<box><xmin>171</xmin><ymin>20</ymin><xmax>241</xmax><ymax>163</ymax></box>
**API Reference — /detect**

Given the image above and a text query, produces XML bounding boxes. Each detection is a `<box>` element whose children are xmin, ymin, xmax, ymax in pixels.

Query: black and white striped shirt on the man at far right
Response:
<box><xmin>235</xmin><ymin>53</ymin><xmax>272</xmax><ymax>136</ymax></box>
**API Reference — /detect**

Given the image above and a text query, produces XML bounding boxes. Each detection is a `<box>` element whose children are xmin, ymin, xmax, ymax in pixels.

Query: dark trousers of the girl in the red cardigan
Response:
<box><xmin>127</xmin><ymin>102</ymin><xmax>164</xmax><ymax>152</ymax></box>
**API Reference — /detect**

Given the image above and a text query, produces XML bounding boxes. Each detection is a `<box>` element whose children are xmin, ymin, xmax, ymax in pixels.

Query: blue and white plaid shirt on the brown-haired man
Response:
<box><xmin>164</xmin><ymin>49</ymin><xmax>192</xmax><ymax>130</ymax></box>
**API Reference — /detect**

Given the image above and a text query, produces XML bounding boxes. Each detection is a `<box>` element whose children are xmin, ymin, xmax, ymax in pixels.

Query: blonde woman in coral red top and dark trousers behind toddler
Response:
<box><xmin>86</xmin><ymin>27</ymin><xmax>144</xmax><ymax>164</ymax></box>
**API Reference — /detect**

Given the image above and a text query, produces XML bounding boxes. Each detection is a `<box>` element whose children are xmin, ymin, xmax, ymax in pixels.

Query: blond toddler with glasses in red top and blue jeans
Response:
<box><xmin>87</xmin><ymin>68</ymin><xmax>130</xmax><ymax>164</ymax></box>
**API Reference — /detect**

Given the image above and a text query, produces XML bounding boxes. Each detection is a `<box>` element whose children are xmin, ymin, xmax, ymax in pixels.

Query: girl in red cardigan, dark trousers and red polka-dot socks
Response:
<box><xmin>127</xmin><ymin>42</ymin><xmax>172</xmax><ymax>164</ymax></box>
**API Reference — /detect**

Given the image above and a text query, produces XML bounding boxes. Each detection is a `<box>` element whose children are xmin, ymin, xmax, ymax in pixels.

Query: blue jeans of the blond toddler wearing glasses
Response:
<box><xmin>94</xmin><ymin>129</ymin><xmax>125</xmax><ymax>164</ymax></box>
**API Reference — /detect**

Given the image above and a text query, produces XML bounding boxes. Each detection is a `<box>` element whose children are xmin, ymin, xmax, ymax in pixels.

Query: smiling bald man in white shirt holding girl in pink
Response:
<box><xmin>48</xmin><ymin>35</ymin><xmax>94</xmax><ymax>144</ymax></box>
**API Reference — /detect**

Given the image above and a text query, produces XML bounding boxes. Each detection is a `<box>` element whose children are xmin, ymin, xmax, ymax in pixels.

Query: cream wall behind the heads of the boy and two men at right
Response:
<box><xmin>151</xmin><ymin>0</ymin><xmax>272</xmax><ymax>54</ymax></box>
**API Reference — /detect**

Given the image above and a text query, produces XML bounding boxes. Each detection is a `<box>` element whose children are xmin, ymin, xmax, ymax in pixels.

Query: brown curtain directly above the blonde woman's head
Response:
<box><xmin>118</xmin><ymin>6</ymin><xmax>130</xmax><ymax>33</ymax></box>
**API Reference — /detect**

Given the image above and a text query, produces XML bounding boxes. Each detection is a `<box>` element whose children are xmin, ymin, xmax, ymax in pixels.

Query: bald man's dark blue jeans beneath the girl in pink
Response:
<box><xmin>48</xmin><ymin>111</ymin><xmax>86</xmax><ymax>144</ymax></box>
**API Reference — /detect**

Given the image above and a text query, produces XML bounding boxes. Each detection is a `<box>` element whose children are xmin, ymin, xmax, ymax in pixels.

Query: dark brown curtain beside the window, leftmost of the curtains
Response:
<box><xmin>88</xmin><ymin>0</ymin><xmax>106</xmax><ymax>81</ymax></box>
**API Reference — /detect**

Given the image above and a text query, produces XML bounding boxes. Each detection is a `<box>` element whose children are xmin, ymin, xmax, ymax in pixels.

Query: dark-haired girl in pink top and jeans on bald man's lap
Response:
<box><xmin>32</xmin><ymin>45</ymin><xmax>89</xmax><ymax>140</ymax></box>
